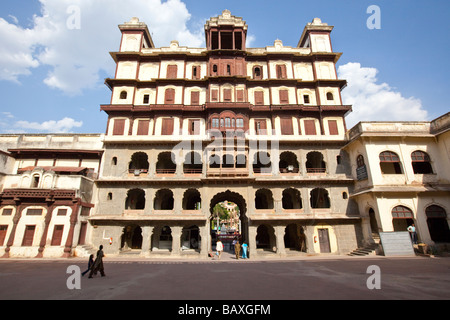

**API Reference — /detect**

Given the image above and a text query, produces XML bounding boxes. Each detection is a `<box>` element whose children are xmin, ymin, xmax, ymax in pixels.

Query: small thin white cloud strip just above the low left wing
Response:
<box><xmin>13</xmin><ymin>117</ymin><xmax>83</xmax><ymax>133</ymax></box>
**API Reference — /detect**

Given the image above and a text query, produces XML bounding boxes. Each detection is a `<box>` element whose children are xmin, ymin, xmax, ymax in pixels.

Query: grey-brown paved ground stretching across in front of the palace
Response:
<box><xmin>0</xmin><ymin>252</ymin><xmax>450</xmax><ymax>302</ymax></box>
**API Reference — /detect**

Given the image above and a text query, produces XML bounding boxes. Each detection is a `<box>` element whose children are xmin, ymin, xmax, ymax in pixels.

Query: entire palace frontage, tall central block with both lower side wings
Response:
<box><xmin>0</xmin><ymin>10</ymin><xmax>450</xmax><ymax>258</ymax></box>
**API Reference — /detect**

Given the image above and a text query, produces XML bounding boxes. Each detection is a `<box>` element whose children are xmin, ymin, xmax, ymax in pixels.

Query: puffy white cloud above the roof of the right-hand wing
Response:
<box><xmin>338</xmin><ymin>62</ymin><xmax>428</xmax><ymax>128</ymax></box>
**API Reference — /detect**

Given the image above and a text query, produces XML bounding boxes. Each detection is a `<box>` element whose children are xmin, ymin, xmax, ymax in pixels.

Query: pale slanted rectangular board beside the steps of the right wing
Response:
<box><xmin>380</xmin><ymin>231</ymin><xmax>415</xmax><ymax>256</ymax></box>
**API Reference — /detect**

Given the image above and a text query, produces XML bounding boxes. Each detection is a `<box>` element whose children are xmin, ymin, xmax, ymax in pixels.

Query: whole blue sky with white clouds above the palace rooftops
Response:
<box><xmin>0</xmin><ymin>0</ymin><xmax>450</xmax><ymax>134</ymax></box>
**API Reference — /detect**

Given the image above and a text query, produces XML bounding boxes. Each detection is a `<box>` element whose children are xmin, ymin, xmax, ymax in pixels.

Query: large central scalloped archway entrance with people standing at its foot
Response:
<box><xmin>209</xmin><ymin>190</ymin><xmax>248</xmax><ymax>252</ymax></box>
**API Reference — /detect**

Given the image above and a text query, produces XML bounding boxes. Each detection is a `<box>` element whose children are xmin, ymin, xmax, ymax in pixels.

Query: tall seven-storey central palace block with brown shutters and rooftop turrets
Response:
<box><xmin>89</xmin><ymin>10</ymin><xmax>361</xmax><ymax>257</ymax></box>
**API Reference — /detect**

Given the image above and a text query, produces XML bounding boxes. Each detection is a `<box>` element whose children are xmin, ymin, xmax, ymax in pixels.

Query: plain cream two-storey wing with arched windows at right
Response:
<box><xmin>343</xmin><ymin>113</ymin><xmax>450</xmax><ymax>250</ymax></box>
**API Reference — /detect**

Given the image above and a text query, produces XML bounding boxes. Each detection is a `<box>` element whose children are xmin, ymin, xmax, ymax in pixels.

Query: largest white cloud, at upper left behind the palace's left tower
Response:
<box><xmin>0</xmin><ymin>0</ymin><xmax>204</xmax><ymax>95</ymax></box>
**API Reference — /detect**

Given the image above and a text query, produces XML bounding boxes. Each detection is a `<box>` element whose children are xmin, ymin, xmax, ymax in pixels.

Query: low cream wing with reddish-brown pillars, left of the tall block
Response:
<box><xmin>0</xmin><ymin>134</ymin><xmax>103</xmax><ymax>257</ymax></box>
